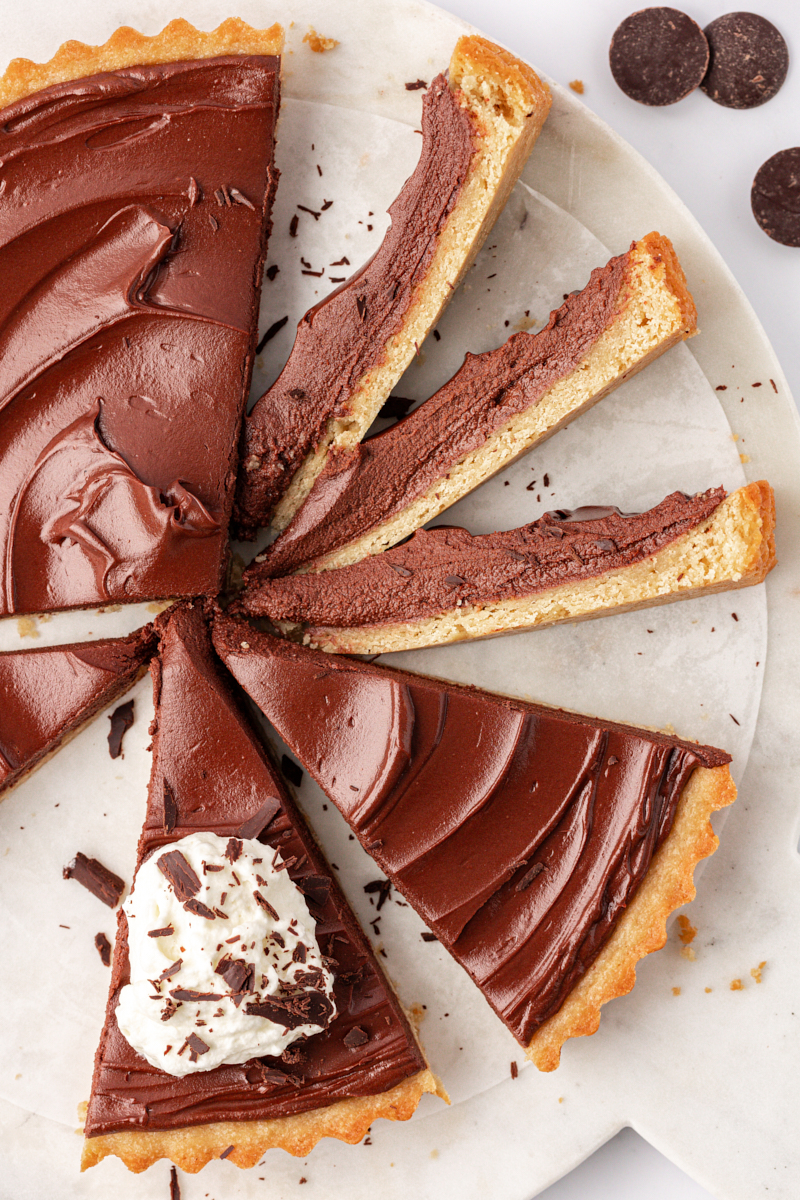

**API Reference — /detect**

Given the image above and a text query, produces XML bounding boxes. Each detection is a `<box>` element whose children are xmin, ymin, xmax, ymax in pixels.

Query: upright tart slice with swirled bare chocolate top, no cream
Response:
<box><xmin>213</xmin><ymin>617</ymin><xmax>735</xmax><ymax>1070</ymax></box>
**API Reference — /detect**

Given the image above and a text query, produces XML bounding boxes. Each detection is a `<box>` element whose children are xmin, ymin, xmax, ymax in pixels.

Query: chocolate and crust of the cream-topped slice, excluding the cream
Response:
<box><xmin>83</xmin><ymin>606</ymin><xmax>441</xmax><ymax>1171</ymax></box>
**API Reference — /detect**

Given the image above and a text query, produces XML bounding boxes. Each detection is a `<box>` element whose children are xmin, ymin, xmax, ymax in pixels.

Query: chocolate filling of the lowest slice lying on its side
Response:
<box><xmin>237</xmin><ymin>487</ymin><xmax>726</xmax><ymax>628</ymax></box>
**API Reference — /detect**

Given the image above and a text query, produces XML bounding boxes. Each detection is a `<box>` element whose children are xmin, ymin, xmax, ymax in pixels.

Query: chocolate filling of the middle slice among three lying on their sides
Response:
<box><xmin>258</xmin><ymin>244</ymin><xmax>630</xmax><ymax>578</ymax></box>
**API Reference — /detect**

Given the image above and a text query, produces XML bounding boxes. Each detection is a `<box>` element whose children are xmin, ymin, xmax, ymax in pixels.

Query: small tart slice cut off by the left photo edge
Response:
<box><xmin>0</xmin><ymin>625</ymin><xmax>156</xmax><ymax>797</ymax></box>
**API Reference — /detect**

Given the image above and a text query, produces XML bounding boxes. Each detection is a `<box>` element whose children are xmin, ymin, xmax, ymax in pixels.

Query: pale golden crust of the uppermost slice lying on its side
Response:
<box><xmin>239</xmin><ymin>37</ymin><xmax>551</xmax><ymax>535</ymax></box>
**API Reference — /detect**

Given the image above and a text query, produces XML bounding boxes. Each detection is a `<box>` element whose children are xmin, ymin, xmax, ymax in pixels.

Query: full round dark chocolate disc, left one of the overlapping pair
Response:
<box><xmin>608</xmin><ymin>8</ymin><xmax>709</xmax><ymax>104</ymax></box>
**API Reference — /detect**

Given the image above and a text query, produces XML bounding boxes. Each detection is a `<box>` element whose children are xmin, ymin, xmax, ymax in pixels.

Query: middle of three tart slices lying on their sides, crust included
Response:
<box><xmin>253</xmin><ymin>233</ymin><xmax>697</xmax><ymax>577</ymax></box>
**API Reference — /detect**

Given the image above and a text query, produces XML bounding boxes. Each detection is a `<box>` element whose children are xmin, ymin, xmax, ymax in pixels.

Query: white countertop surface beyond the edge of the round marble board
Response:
<box><xmin>439</xmin><ymin>0</ymin><xmax>800</xmax><ymax>1200</ymax></box>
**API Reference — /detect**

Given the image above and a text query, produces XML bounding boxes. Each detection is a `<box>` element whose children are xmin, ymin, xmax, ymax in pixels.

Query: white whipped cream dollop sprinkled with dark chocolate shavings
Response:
<box><xmin>116</xmin><ymin>833</ymin><xmax>336</xmax><ymax>1075</ymax></box>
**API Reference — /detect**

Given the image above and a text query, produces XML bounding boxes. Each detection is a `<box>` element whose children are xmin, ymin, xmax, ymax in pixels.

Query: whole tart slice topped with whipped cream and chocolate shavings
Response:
<box><xmin>83</xmin><ymin>606</ymin><xmax>439</xmax><ymax>1171</ymax></box>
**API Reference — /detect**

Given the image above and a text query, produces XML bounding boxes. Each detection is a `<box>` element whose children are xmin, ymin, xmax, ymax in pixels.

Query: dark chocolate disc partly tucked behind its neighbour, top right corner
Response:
<box><xmin>700</xmin><ymin>12</ymin><xmax>789</xmax><ymax>108</ymax></box>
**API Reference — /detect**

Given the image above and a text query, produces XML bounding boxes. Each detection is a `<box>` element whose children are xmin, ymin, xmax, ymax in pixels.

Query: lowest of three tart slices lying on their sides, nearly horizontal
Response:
<box><xmin>236</xmin><ymin>481</ymin><xmax>776</xmax><ymax>654</ymax></box>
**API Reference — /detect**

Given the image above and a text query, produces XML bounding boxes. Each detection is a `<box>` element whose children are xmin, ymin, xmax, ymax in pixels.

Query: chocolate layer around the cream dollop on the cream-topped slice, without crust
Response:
<box><xmin>85</xmin><ymin>607</ymin><xmax>425</xmax><ymax>1138</ymax></box>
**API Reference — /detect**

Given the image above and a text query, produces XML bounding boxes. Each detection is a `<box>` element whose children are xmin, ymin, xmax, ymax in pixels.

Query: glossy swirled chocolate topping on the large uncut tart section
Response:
<box><xmin>0</xmin><ymin>56</ymin><xmax>279</xmax><ymax>613</ymax></box>
